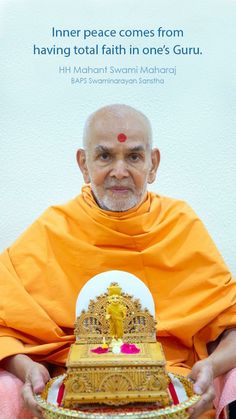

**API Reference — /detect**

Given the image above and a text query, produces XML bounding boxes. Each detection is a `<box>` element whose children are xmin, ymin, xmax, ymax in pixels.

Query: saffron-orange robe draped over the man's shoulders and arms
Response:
<box><xmin>0</xmin><ymin>186</ymin><xmax>236</xmax><ymax>368</ymax></box>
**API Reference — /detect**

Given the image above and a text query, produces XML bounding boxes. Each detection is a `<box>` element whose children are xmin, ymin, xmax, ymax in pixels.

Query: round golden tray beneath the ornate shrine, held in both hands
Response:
<box><xmin>35</xmin><ymin>374</ymin><xmax>200</xmax><ymax>419</ymax></box>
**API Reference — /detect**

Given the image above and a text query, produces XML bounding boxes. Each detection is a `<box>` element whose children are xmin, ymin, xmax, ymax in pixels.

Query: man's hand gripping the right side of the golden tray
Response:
<box><xmin>188</xmin><ymin>358</ymin><xmax>215</xmax><ymax>419</ymax></box>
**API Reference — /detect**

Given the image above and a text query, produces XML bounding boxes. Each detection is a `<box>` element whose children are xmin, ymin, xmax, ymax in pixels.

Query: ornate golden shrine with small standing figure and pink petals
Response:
<box><xmin>61</xmin><ymin>283</ymin><xmax>170</xmax><ymax>409</ymax></box>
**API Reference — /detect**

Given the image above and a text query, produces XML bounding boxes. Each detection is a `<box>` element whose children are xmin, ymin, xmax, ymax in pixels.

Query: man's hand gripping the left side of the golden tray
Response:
<box><xmin>21</xmin><ymin>362</ymin><xmax>50</xmax><ymax>419</ymax></box>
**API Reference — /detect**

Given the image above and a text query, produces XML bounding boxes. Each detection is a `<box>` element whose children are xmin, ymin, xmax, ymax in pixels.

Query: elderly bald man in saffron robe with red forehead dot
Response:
<box><xmin>0</xmin><ymin>105</ymin><xmax>236</xmax><ymax>418</ymax></box>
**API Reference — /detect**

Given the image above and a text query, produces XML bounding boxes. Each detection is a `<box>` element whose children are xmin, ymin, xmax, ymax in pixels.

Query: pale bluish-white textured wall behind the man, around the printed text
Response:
<box><xmin>0</xmin><ymin>0</ymin><xmax>236</xmax><ymax>274</ymax></box>
